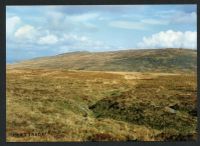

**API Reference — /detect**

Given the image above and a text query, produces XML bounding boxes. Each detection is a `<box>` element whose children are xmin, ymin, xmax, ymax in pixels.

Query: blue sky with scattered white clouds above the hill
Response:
<box><xmin>6</xmin><ymin>5</ymin><xmax>197</xmax><ymax>63</ymax></box>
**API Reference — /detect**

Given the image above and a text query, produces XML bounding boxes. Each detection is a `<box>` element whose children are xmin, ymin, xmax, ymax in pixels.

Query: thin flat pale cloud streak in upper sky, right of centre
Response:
<box><xmin>109</xmin><ymin>21</ymin><xmax>145</xmax><ymax>30</ymax></box>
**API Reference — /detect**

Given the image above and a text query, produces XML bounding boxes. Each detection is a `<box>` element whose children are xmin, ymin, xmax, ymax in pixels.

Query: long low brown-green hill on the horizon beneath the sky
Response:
<box><xmin>7</xmin><ymin>48</ymin><xmax>197</xmax><ymax>72</ymax></box>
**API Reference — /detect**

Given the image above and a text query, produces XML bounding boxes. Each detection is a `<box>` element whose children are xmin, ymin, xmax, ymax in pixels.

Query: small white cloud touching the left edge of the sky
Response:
<box><xmin>6</xmin><ymin>16</ymin><xmax>21</xmax><ymax>36</ymax></box>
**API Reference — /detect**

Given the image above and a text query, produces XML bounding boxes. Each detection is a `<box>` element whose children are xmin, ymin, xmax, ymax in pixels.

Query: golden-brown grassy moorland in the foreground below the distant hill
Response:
<box><xmin>6</xmin><ymin>48</ymin><xmax>197</xmax><ymax>141</ymax></box>
